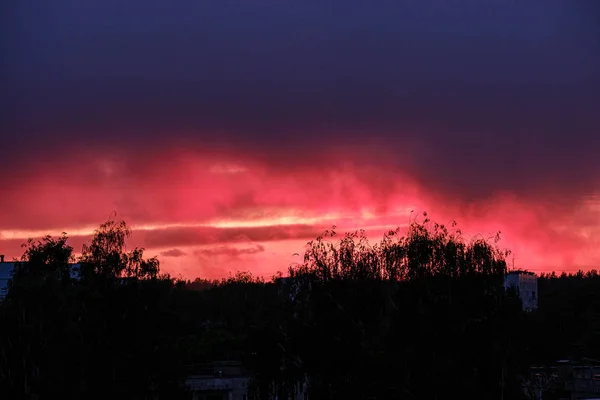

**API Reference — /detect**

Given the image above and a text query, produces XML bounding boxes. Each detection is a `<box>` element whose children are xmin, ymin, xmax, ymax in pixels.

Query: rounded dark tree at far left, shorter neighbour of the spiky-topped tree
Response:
<box><xmin>0</xmin><ymin>234</ymin><xmax>78</xmax><ymax>395</ymax></box>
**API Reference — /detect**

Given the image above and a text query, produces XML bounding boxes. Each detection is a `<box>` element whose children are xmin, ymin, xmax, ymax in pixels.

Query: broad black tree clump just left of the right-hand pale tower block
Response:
<box><xmin>276</xmin><ymin>214</ymin><xmax>520</xmax><ymax>399</ymax></box>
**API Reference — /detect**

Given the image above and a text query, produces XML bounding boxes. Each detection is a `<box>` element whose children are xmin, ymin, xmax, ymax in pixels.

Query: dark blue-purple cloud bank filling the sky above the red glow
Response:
<box><xmin>0</xmin><ymin>0</ymin><xmax>600</xmax><ymax>203</ymax></box>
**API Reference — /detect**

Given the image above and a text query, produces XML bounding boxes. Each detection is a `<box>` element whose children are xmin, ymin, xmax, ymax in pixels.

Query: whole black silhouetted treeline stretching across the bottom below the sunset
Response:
<box><xmin>0</xmin><ymin>219</ymin><xmax>600</xmax><ymax>399</ymax></box>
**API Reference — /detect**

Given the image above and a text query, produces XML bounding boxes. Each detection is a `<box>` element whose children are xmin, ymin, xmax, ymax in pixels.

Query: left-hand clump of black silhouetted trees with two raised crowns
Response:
<box><xmin>0</xmin><ymin>221</ymin><xmax>186</xmax><ymax>398</ymax></box>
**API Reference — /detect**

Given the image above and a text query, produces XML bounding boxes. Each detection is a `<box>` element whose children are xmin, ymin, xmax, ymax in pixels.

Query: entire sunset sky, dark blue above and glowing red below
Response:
<box><xmin>0</xmin><ymin>0</ymin><xmax>600</xmax><ymax>279</ymax></box>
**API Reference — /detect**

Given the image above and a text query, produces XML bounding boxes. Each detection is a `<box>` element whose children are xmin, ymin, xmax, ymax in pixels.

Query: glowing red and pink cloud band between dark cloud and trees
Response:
<box><xmin>0</xmin><ymin>148</ymin><xmax>600</xmax><ymax>278</ymax></box>
